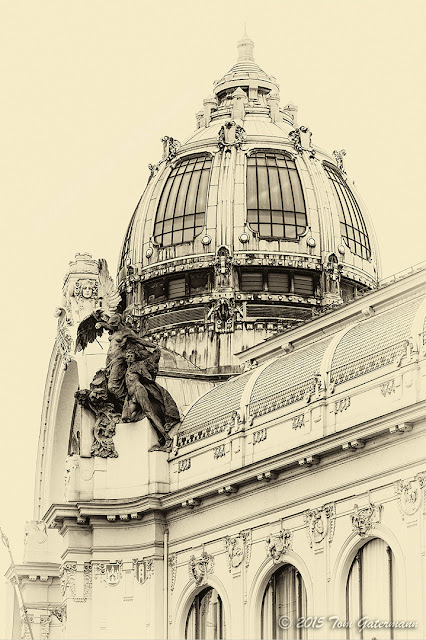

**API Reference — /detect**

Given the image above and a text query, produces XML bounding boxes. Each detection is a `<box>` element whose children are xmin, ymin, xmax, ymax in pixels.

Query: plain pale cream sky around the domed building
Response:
<box><xmin>0</xmin><ymin>0</ymin><xmax>426</xmax><ymax>620</ymax></box>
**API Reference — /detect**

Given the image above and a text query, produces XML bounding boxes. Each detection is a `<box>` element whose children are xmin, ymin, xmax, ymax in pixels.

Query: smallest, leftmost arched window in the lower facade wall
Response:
<box><xmin>185</xmin><ymin>587</ymin><xmax>225</xmax><ymax>640</ymax></box>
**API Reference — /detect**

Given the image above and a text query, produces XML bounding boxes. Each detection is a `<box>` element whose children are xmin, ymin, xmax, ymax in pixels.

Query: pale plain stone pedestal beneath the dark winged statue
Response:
<box><xmin>93</xmin><ymin>418</ymin><xmax>170</xmax><ymax>500</ymax></box>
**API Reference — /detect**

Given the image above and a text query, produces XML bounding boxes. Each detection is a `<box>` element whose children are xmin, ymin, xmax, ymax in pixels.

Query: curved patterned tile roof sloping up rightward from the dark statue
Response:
<box><xmin>178</xmin><ymin>295</ymin><xmax>426</xmax><ymax>446</ymax></box>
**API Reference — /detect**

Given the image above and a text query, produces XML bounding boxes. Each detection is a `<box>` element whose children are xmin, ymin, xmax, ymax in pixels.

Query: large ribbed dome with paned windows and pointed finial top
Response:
<box><xmin>118</xmin><ymin>36</ymin><xmax>379</xmax><ymax>373</ymax></box>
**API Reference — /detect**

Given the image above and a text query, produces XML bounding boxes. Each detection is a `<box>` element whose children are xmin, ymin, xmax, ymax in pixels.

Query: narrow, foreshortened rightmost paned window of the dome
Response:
<box><xmin>323</xmin><ymin>163</ymin><xmax>371</xmax><ymax>260</ymax></box>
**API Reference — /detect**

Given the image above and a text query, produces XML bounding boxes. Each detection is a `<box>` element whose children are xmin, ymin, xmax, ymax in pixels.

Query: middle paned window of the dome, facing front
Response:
<box><xmin>247</xmin><ymin>151</ymin><xmax>307</xmax><ymax>240</ymax></box>
